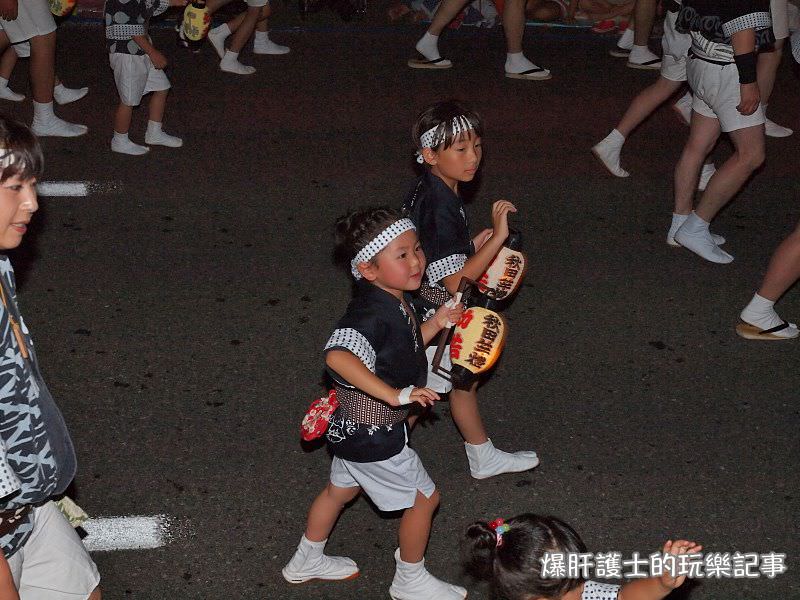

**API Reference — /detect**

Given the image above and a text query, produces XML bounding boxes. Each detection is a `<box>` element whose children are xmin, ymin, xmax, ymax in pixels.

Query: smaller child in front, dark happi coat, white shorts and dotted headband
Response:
<box><xmin>283</xmin><ymin>208</ymin><xmax>466</xmax><ymax>600</ymax></box>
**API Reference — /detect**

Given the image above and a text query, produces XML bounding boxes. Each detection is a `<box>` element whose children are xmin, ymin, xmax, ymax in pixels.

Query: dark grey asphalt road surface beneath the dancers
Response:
<box><xmin>3</xmin><ymin>15</ymin><xmax>800</xmax><ymax>600</ymax></box>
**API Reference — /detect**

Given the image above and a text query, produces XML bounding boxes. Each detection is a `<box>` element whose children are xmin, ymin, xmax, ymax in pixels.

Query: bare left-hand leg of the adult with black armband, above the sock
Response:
<box><xmin>673</xmin><ymin>112</ymin><xmax>720</xmax><ymax>215</ymax></box>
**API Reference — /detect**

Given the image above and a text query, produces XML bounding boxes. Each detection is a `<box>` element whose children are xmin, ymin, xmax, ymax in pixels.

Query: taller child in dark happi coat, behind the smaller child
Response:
<box><xmin>402</xmin><ymin>101</ymin><xmax>539</xmax><ymax>479</ymax></box>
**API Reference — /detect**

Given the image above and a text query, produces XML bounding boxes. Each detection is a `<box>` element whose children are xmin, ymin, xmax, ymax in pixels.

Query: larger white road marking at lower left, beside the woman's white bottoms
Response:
<box><xmin>82</xmin><ymin>515</ymin><xmax>171</xmax><ymax>552</ymax></box>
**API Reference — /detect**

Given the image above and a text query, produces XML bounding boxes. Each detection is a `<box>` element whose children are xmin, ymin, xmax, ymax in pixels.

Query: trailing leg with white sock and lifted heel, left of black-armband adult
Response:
<box><xmin>592</xmin><ymin>77</ymin><xmax>682</xmax><ymax>177</ymax></box>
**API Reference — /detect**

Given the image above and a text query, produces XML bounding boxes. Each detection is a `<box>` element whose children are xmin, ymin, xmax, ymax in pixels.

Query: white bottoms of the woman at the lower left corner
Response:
<box><xmin>8</xmin><ymin>502</ymin><xmax>100</xmax><ymax>600</ymax></box>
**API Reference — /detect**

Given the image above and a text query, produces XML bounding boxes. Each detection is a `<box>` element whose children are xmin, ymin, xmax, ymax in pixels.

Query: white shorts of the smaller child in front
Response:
<box><xmin>331</xmin><ymin>446</ymin><xmax>436</xmax><ymax>512</ymax></box>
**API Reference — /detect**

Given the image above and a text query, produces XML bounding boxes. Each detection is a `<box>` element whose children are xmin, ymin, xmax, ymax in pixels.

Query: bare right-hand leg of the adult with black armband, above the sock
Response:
<box><xmin>692</xmin><ymin>123</ymin><xmax>764</xmax><ymax>223</ymax></box>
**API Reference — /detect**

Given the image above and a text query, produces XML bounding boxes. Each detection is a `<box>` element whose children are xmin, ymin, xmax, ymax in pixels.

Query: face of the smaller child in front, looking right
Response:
<box><xmin>365</xmin><ymin>230</ymin><xmax>425</xmax><ymax>295</ymax></box>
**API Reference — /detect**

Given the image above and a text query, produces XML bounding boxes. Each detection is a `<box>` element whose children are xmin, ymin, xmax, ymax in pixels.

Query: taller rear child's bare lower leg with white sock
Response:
<box><xmin>450</xmin><ymin>383</ymin><xmax>539</xmax><ymax>479</ymax></box>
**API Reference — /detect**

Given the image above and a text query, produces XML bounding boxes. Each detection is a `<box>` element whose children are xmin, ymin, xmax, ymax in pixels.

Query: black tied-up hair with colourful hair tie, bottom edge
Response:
<box><xmin>461</xmin><ymin>513</ymin><xmax>586</xmax><ymax>600</ymax></box>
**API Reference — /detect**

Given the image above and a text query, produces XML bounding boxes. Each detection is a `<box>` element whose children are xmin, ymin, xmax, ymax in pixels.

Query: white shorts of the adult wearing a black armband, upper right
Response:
<box><xmin>687</xmin><ymin>58</ymin><xmax>765</xmax><ymax>132</ymax></box>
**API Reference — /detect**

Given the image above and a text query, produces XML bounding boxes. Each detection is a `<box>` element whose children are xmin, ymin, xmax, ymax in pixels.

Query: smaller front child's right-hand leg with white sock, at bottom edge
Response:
<box><xmin>389</xmin><ymin>490</ymin><xmax>467</xmax><ymax>600</ymax></box>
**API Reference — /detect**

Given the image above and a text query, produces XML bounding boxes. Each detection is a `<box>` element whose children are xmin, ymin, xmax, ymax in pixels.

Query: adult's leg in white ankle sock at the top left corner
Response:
<box><xmin>30</xmin><ymin>31</ymin><xmax>89</xmax><ymax>137</ymax></box>
